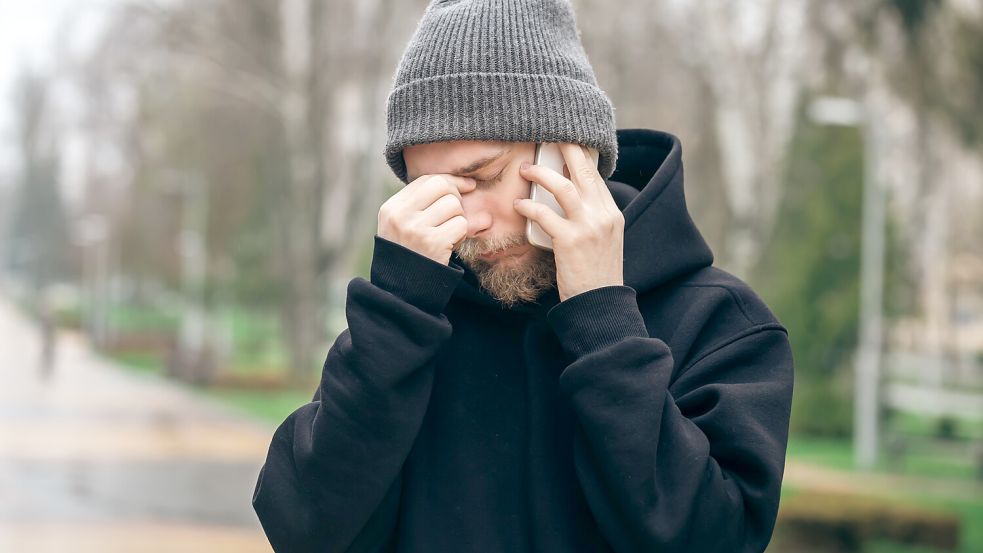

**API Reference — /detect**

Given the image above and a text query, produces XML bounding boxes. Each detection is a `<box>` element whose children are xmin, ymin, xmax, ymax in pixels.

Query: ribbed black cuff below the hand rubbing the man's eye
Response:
<box><xmin>369</xmin><ymin>234</ymin><xmax>464</xmax><ymax>313</ymax></box>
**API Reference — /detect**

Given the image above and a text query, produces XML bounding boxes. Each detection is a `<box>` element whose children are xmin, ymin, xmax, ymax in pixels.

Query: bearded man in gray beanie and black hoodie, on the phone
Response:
<box><xmin>253</xmin><ymin>0</ymin><xmax>793</xmax><ymax>552</ymax></box>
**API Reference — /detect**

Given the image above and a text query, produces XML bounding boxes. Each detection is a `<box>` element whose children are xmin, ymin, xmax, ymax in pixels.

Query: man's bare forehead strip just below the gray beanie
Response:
<box><xmin>403</xmin><ymin>140</ymin><xmax>513</xmax><ymax>180</ymax></box>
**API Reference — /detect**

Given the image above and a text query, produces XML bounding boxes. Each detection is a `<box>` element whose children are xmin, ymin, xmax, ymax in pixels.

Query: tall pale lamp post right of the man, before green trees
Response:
<box><xmin>809</xmin><ymin>96</ymin><xmax>886</xmax><ymax>469</ymax></box>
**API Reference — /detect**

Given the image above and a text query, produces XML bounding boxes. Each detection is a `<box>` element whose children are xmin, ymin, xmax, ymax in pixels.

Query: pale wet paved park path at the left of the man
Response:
<box><xmin>0</xmin><ymin>297</ymin><xmax>273</xmax><ymax>553</ymax></box>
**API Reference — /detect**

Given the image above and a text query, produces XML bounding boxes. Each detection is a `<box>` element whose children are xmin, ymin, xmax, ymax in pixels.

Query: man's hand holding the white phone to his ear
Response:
<box><xmin>515</xmin><ymin>144</ymin><xmax>625</xmax><ymax>301</ymax></box>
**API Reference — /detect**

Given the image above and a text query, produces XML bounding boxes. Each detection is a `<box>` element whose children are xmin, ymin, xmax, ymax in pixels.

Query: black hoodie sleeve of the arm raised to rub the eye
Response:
<box><xmin>252</xmin><ymin>235</ymin><xmax>464</xmax><ymax>553</ymax></box>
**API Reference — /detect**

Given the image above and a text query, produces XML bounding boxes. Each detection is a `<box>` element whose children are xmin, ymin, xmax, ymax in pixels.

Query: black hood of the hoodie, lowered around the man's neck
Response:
<box><xmin>451</xmin><ymin>129</ymin><xmax>713</xmax><ymax>315</ymax></box>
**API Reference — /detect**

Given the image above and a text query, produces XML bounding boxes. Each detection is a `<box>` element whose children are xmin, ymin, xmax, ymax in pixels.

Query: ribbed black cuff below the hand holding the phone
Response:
<box><xmin>546</xmin><ymin>285</ymin><xmax>649</xmax><ymax>360</ymax></box>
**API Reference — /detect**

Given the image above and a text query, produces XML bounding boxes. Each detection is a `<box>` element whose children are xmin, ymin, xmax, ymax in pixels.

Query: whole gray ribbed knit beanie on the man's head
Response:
<box><xmin>385</xmin><ymin>0</ymin><xmax>618</xmax><ymax>183</ymax></box>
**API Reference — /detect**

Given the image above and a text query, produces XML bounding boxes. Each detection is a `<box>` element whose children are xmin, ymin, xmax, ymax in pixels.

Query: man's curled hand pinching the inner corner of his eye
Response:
<box><xmin>377</xmin><ymin>175</ymin><xmax>475</xmax><ymax>265</ymax></box>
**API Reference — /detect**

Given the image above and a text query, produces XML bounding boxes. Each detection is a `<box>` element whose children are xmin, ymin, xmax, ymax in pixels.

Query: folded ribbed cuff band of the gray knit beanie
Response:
<box><xmin>385</xmin><ymin>73</ymin><xmax>618</xmax><ymax>183</ymax></box>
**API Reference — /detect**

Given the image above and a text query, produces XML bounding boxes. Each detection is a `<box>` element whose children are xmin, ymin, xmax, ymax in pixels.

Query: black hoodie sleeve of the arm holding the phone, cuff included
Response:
<box><xmin>548</xmin><ymin>286</ymin><xmax>793</xmax><ymax>553</ymax></box>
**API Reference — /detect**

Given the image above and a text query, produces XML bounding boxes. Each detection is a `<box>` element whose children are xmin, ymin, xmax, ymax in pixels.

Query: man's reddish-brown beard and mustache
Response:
<box><xmin>457</xmin><ymin>233</ymin><xmax>556</xmax><ymax>307</ymax></box>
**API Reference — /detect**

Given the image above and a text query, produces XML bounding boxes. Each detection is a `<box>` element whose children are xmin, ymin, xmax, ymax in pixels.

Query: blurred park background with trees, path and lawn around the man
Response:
<box><xmin>0</xmin><ymin>0</ymin><xmax>983</xmax><ymax>553</ymax></box>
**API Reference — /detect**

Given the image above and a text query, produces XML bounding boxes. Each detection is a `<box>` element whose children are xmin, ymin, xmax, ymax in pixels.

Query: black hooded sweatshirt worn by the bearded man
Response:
<box><xmin>253</xmin><ymin>129</ymin><xmax>793</xmax><ymax>553</ymax></box>
